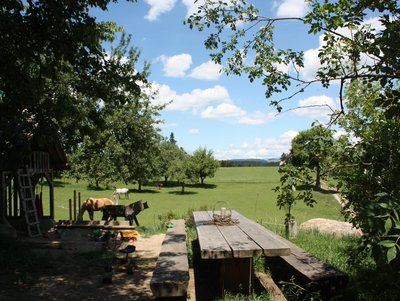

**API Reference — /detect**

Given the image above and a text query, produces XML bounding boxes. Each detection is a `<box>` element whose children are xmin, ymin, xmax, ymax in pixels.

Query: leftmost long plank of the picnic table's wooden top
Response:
<box><xmin>193</xmin><ymin>211</ymin><xmax>232</xmax><ymax>259</ymax></box>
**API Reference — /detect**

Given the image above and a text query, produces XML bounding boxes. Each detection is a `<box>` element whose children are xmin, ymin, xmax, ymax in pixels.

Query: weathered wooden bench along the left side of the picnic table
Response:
<box><xmin>150</xmin><ymin>219</ymin><xmax>189</xmax><ymax>298</ymax></box>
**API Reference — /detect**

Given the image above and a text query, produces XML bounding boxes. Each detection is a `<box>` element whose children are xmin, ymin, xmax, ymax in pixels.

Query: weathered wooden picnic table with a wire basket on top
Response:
<box><xmin>193</xmin><ymin>210</ymin><xmax>290</xmax><ymax>294</ymax></box>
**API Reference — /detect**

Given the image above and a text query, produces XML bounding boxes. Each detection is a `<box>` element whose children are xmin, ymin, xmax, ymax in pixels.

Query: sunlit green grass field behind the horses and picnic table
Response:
<box><xmin>39</xmin><ymin>167</ymin><xmax>342</xmax><ymax>227</ymax></box>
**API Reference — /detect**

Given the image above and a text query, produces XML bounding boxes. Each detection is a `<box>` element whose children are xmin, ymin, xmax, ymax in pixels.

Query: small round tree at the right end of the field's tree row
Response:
<box><xmin>191</xmin><ymin>147</ymin><xmax>219</xmax><ymax>185</ymax></box>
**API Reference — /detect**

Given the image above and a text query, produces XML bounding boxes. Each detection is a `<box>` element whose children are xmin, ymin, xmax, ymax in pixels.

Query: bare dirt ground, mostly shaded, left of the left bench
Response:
<box><xmin>0</xmin><ymin>229</ymin><xmax>200</xmax><ymax>301</ymax></box>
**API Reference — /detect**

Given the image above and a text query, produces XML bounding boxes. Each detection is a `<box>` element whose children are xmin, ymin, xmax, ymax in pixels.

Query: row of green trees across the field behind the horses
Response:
<box><xmin>65</xmin><ymin>133</ymin><xmax>219</xmax><ymax>193</ymax></box>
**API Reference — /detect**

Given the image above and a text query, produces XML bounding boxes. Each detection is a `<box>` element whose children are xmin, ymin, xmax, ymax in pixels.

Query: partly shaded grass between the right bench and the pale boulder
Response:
<box><xmin>286</xmin><ymin>231</ymin><xmax>400</xmax><ymax>301</ymax></box>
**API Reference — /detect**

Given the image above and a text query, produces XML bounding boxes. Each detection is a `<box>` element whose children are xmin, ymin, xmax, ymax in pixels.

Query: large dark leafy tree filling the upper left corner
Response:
<box><xmin>0</xmin><ymin>0</ymin><xmax>144</xmax><ymax>151</ymax></box>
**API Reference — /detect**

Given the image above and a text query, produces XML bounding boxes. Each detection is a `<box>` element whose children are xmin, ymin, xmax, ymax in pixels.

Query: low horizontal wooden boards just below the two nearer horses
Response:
<box><xmin>55</xmin><ymin>220</ymin><xmax>136</xmax><ymax>230</ymax></box>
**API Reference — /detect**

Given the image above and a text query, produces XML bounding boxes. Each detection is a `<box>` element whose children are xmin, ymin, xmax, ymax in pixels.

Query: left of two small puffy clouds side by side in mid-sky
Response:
<box><xmin>156</xmin><ymin>53</ymin><xmax>192</xmax><ymax>77</ymax></box>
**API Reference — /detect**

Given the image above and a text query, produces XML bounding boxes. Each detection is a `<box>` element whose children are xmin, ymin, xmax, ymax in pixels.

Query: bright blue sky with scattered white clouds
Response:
<box><xmin>94</xmin><ymin>0</ymin><xmax>382</xmax><ymax>159</ymax></box>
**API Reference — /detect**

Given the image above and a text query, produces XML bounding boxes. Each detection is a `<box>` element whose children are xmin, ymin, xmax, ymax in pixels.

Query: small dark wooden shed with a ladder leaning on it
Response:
<box><xmin>0</xmin><ymin>132</ymin><xmax>68</xmax><ymax>236</ymax></box>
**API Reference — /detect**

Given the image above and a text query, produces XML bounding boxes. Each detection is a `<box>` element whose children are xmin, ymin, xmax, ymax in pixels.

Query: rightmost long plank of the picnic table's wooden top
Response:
<box><xmin>232</xmin><ymin>211</ymin><xmax>290</xmax><ymax>256</ymax></box>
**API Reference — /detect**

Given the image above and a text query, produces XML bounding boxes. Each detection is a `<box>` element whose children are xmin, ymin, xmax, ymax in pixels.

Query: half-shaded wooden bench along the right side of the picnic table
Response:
<box><xmin>267</xmin><ymin>230</ymin><xmax>348</xmax><ymax>296</ymax></box>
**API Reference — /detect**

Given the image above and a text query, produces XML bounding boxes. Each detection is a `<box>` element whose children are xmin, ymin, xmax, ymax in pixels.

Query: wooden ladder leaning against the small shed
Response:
<box><xmin>18</xmin><ymin>172</ymin><xmax>41</xmax><ymax>237</ymax></box>
